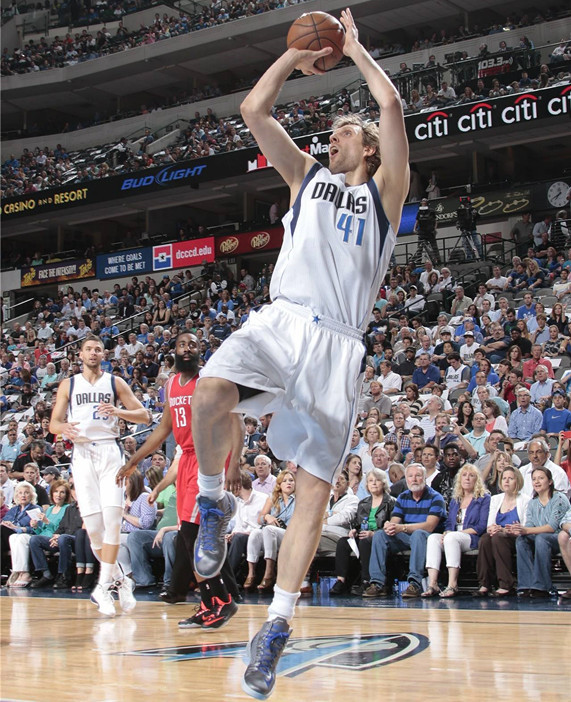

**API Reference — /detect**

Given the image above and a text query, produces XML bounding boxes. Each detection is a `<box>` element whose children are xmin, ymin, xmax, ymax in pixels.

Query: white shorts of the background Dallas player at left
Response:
<box><xmin>71</xmin><ymin>441</ymin><xmax>125</xmax><ymax>517</ymax></box>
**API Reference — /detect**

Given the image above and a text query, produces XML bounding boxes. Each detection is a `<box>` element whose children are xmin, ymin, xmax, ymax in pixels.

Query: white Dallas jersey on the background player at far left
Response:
<box><xmin>68</xmin><ymin>373</ymin><xmax>119</xmax><ymax>443</ymax></box>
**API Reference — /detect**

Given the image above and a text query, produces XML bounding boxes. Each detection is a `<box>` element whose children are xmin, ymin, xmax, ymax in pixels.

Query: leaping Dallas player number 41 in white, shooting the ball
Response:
<box><xmin>192</xmin><ymin>9</ymin><xmax>409</xmax><ymax>699</ymax></box>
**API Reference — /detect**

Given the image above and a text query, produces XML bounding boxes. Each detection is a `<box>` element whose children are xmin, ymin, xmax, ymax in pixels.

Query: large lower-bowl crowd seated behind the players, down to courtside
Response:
<box><xmin>0</xmin><ymin>230</ymin><xmax>571</xmax><ymax>601</ymax></box>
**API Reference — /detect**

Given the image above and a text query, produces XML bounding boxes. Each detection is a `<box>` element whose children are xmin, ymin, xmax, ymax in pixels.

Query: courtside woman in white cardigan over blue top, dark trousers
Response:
<box><xmin>475</xmin><ymin>466</ymin><xmax>530</xmax><ymax>597</ymax></box>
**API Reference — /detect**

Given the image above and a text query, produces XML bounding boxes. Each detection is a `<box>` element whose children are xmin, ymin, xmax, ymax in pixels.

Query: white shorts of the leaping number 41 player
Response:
<box><xmin>199</xmin><ymin>300</ymin><xmax>365</xmax><ymax>482</ymax></box>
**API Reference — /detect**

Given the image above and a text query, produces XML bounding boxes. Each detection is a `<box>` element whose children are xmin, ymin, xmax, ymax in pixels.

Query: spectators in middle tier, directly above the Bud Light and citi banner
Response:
<box><xmin>1</xmin><ymin>49</ymin><xmax>571</xmax><ymax>198</ymax></box>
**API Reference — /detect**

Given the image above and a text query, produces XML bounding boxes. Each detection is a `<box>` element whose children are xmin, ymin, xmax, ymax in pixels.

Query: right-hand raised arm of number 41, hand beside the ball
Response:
<box><xmin>341</xmin><ymin>9</ymin><xmax>410</xmax><ymax>232</ymax></box>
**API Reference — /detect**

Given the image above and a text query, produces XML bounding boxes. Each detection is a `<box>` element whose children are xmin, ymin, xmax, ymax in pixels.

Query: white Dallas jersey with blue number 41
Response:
<box><xmin>270</xmin><ymin>163</ymin><xmax>396</xmax><ymax>330</ymax></box>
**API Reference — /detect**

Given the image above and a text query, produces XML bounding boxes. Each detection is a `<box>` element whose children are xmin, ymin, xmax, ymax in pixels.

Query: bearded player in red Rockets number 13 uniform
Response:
<box><xmin>117</xmin><ymin>332</ymin><xmax>244</xmax><ymax>629</ymax></box>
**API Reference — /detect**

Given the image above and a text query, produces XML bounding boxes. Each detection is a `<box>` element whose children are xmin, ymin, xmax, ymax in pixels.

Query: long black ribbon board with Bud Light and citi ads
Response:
<box><xmin>1</xmin><ymin>85</ymin><xmax>571</xmax><ymax>221</ymax></box>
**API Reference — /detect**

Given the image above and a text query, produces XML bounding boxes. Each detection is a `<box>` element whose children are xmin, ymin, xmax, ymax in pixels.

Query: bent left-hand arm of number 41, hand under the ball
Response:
<box><xmin>240</xmin><ymin>47</ymin><xmax>332</xmax><ymax>195</ymax></box>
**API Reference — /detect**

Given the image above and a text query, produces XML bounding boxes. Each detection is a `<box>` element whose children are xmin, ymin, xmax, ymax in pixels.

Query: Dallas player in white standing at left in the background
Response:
<box><xmin>50</xmin><ymin>334</ymin><xmax>152</xmax><ymax>617</ymax></box>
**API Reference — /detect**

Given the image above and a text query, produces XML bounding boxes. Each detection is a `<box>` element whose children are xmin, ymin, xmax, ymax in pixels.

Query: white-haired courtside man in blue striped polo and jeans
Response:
<box><xmin>363</xmin><ymin>463</ymin><xmax>446</xmax><ymax>597</ymax></box>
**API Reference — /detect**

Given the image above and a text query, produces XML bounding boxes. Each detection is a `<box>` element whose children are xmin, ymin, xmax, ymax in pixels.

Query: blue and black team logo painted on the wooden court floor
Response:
<box><xmin>120</xmin><ymin>633</ymin><xmax>429</xmax><ymax>678</ymax></box>
